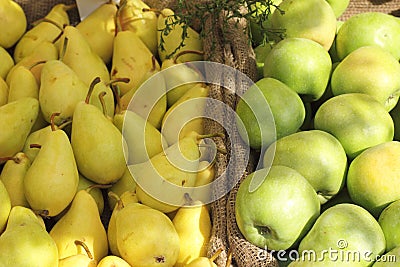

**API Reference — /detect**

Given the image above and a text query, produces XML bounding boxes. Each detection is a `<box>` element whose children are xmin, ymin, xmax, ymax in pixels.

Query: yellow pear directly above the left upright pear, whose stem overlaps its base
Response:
<box><xmin>39</xmin><ymin>60</ymin><xmax>89</xmax><ymax>125</ymax></box>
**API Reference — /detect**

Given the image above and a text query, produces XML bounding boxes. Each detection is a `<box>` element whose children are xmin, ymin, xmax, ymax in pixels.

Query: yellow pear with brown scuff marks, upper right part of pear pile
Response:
<box><xmin>111</xmin><ymin>31</ymin><xmax>160</xmax><ymax>95</ymax></box>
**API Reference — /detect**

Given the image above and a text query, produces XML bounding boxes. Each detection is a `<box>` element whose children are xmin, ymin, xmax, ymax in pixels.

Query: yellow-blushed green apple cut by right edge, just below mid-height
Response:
<box><xmin>347</xmin><ymin>141</ymin><xmax>400</xmax><ymax>217</ymax></box>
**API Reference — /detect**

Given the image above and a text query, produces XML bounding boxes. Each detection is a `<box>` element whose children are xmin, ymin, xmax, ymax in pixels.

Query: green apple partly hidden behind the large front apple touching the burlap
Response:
<box><xmin>263</xmin><ymin>130</ymin><xmax>347</xmax><ymax>204</ymax></box>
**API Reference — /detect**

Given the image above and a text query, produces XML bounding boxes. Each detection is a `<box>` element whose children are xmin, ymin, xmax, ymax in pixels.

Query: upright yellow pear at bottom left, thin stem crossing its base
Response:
<box><xmin>50</xmin><ymin>190</ymin><xmax>108</xmax><ymax>262</ymax></box>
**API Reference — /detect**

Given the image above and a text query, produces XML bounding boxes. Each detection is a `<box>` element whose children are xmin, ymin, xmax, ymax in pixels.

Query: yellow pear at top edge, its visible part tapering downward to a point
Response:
<box><xmin>76</xmin><ymin>1</ymin><xmax>117</xmax><ymax>64</ymax></box>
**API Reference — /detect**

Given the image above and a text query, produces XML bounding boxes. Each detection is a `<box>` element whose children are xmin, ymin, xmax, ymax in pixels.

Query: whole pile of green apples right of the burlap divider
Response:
<box><xmin>235</xmin><ymin>0</ymin><xmax>400</xmax><ymax>266</ymax></box>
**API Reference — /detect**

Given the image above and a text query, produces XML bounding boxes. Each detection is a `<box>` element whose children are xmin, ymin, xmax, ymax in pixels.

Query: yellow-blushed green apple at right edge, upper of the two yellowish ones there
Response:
<box><xmin>331</xmin><ymin>46</ymin><xmax>400</xmax><ymax>111</ymax></box>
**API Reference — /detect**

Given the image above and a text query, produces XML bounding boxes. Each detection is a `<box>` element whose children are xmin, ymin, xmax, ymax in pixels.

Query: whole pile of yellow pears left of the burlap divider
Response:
<box><xmin>0</xmin><ymin>0</ymin><xmax>222</xmax><ymax>267</ymax></box>
